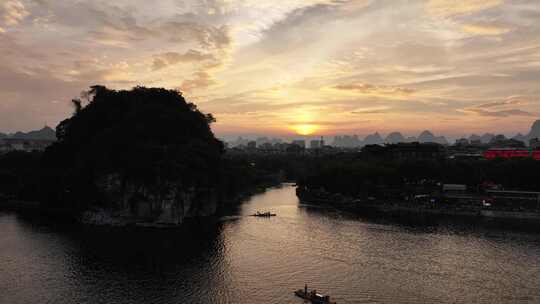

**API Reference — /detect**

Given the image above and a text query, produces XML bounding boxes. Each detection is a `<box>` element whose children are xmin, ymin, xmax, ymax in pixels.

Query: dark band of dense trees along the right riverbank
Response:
<box><xmin>299</xmin><ymin>154</ymin><xmax>540</xmax><ymax>195</ymax></box>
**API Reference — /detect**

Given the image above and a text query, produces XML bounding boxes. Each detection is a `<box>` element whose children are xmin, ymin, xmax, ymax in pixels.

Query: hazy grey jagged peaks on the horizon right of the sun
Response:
<box><xmin>332</xmin><ymin>120</ymin><xmax>540</xmax><ymax>148</ymax></box>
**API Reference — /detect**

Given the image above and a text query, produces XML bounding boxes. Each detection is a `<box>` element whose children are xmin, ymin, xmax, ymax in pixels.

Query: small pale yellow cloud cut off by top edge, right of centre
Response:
<box><xmin>426</xmin><ymin>0</ymin><xmax>504</xmax><ymax>17</ymax></box>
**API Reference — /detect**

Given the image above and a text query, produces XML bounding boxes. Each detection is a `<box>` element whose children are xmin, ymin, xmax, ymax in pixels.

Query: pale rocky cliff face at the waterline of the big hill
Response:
<box><xmin>81</xmin><ymin>174</ymin><xmax>217</xmax><ymax>226</ymax></box>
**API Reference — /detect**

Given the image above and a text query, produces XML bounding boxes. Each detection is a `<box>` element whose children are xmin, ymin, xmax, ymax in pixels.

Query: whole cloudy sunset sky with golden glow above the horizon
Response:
<box><xmin>0</xmin><ymin>0</ymin><xmax>540</xmax><ymax>136</ymax></box>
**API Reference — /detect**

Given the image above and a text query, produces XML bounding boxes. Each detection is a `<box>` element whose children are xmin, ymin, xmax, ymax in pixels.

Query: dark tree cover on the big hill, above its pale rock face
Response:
<box><xmin>45</xmin><ymin>86</ymin><xmax>223</xmax><ymax>184</ymax></box>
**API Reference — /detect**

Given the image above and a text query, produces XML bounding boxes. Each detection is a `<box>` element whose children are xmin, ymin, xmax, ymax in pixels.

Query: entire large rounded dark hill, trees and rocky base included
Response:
<box><xmin>43</xmin><ymin>86</ymin><xmax>223</xmax><ymax>222</ymax></box>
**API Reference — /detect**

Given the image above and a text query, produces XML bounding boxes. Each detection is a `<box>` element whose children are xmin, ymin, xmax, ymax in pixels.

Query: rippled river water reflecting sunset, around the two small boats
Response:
<box><xmin>0</xmin><ymin>186</ymin><xmax>540</xmax><ymax>304</ymax></box>
